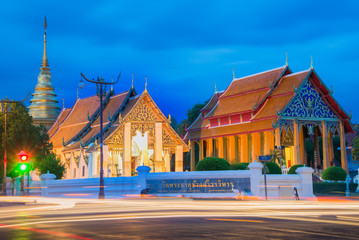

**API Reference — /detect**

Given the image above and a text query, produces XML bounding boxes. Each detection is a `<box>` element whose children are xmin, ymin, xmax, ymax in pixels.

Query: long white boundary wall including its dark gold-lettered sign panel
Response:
<box><xmin>7</xmin><ymin>162</ymin><xmax>315</xmax><ymax>199</ymax></box>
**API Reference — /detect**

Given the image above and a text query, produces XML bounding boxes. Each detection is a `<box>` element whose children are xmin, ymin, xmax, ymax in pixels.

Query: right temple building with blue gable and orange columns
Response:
<box><xmin>185</xmin><ymin>65</ymin><xmax>353</xmax><ymax>171</ymax></box>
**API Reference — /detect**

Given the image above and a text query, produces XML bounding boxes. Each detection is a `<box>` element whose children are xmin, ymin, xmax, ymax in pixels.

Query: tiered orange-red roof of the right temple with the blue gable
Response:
<box><xmin>185</xmin><ymin>66</ymin><xmax>353</xmax><ymax>140</ymax></box>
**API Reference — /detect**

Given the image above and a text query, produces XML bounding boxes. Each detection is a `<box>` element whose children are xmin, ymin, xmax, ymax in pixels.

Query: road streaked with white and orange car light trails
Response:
<box><xmin>0</xmin><ymin>198</ymin><xmax>359</xmax><ymax>240</ymax></box>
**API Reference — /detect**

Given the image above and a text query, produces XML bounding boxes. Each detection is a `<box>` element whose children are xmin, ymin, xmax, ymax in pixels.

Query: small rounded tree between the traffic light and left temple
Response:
<box><xmin>35</xmin><ymin>153</ymin><xmax>66</xmax><ymax>179</ymax></box>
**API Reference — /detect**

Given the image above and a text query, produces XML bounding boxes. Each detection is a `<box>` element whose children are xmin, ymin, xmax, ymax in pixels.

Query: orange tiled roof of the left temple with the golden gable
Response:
<box><xmin>49</xmin><ymin>88</ymin><xmax>188</xmax><ymax>152</ymax></box>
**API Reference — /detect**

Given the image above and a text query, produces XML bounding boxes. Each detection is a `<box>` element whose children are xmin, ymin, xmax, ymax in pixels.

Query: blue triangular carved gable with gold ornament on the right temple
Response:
<box><xmin>281</xmin><ymin>79</ymin><xmax>337</xmax><ymax>118</ymax></box>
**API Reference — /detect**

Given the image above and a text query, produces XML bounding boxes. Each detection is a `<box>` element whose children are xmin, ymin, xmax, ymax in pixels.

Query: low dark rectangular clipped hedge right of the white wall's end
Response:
<box><xmin>313</xmin><ymin>182</ymin><xmax>358</xmax><ymax>196</ymax></box>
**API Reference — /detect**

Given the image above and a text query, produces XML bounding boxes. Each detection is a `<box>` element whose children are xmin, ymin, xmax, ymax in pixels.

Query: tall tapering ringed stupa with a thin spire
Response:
<box><xmin>28</xmin><ymin>17</ymin><xmax>60</xmax><ymax>129</ymax></box>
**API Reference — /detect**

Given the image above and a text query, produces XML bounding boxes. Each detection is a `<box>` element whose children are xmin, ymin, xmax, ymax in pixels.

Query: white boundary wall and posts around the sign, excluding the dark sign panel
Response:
<box><xmin>7</xmin><ymin>162</ymin><xmax>315</xmax><ymax>199</ymax></box>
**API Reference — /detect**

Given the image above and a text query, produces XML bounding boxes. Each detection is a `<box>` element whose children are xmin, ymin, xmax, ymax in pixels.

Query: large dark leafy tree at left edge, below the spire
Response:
<box><xmin>0</xmin><ymin>103</ymin><xmax>52</xmax><ymax>182</ymax></box>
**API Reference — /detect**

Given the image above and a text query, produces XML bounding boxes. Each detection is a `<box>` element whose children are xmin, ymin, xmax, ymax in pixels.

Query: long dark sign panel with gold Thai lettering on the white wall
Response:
<box><xmin>147</xmin><ymin>177</ymin><xmax>251</xmax><ymax>193</ymax></box>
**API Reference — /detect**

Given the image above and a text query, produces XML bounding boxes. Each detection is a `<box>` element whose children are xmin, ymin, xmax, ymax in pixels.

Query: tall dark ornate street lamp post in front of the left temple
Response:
<box><xmin>79</xmin><ymin>73</ymin><xmax>121</xmax><ymax>199</ymax></box>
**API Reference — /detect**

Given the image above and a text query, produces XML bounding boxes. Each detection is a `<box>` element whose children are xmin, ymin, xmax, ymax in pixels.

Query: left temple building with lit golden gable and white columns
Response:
<box><xmin>48</xmin><ymin>83</ymin><xmax>189</xmax><ymax>179</ymax></box>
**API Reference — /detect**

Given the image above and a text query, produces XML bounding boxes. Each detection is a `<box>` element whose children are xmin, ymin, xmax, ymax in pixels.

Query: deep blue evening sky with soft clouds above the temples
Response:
<box><xmin>0</xmin><ymin>0</ymin><xmax>359</xmax><ymax>121</ymax></box>
